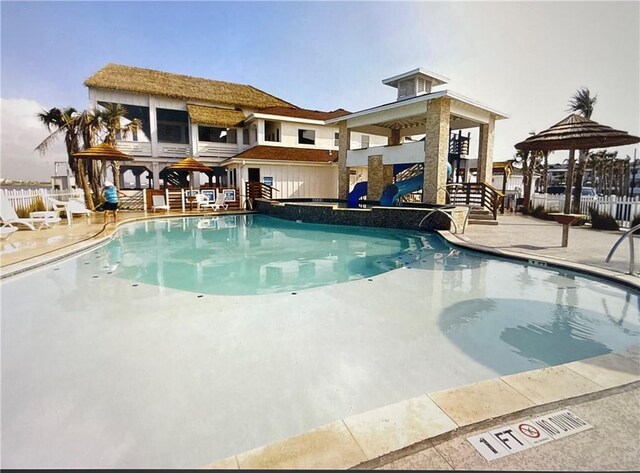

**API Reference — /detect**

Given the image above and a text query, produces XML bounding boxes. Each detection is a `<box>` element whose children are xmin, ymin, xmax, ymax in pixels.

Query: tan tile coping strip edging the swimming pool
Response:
<box><xmin>0</xmin><ymin>212</ymin><xmax>640</xmax><ymax>469</ymax></box>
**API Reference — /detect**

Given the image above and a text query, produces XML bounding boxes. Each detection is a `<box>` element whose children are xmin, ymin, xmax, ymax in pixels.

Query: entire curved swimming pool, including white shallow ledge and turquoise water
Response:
<box><xmin>2</xmin><ymin>216</ymin><xmax>640</xmax><ymax>468</ymax></box>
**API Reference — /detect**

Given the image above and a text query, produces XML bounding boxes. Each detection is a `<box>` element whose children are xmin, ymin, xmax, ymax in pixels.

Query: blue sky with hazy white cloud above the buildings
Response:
<box><xmin>0</xmin><ymin>0</ymin><xmax>640</xmax><ymax>180</ymax></box>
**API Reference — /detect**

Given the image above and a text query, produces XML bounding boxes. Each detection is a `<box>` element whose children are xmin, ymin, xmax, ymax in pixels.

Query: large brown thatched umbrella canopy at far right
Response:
<box><xmin>515</xmin><ymin>114</ymin><xmax>640</xmax><ymax>151</ymax></box>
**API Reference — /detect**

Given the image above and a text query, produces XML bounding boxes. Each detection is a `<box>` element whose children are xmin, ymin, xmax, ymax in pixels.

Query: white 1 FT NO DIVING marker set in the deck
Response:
<box><xmin>467</xmin><ymin>409</ymin><xmax>592</xmax><ymax>461</ymax></box>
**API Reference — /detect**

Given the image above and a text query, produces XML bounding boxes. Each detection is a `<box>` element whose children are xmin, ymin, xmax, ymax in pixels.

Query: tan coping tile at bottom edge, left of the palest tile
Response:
<box><xmin>237</xmin><ymin>421</ymin><xmax>367</xmax><ymax>469</ymax></box>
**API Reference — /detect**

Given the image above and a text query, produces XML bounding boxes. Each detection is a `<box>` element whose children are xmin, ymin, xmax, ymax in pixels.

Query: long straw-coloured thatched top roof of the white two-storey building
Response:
<box><xmin>84</xmin><ymin>64</ymin><xmax>295</xmax><ymax>108</ymax></box>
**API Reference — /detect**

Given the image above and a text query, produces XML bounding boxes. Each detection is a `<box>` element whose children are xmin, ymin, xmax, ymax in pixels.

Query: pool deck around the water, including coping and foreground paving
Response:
<box><xmin>0</xmin><ymin>212</ymin><xmax>640</xmax><ymax>471</ymax></box>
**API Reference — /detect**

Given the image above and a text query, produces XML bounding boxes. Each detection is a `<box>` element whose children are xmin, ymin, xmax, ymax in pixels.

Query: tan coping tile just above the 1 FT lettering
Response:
<box><xmin>429</xmin><ymin>378</ymin><xmax>535</xmax><ymax>427</ymax></box>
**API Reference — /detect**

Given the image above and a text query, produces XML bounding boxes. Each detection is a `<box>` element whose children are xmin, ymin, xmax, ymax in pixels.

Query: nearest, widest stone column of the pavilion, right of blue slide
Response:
<box><xmin>422</xmin><ymin>97</ymin><xmax>451</xmax><ymax>204</ymax></box>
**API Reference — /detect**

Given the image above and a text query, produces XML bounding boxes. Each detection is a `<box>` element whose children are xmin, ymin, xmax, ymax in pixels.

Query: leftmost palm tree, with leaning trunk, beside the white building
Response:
<box><xmin>35</xmin><ymin>107</ymin><xmax>94</xmax><ymax>210</ymax></box>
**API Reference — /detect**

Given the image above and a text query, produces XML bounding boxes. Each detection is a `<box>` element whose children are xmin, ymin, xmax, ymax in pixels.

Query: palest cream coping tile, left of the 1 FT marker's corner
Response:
<box><xmin>344</xmin><ymin>395</ymin><xmax>458</xmax><ymax>460</ymax></box>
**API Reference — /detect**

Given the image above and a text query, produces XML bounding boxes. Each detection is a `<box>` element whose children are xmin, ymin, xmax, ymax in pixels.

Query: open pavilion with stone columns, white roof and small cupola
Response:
<box><xmin>327</xmin><ymin>68</ymin><xmax>507</xmax><ymax>204</ymax></box>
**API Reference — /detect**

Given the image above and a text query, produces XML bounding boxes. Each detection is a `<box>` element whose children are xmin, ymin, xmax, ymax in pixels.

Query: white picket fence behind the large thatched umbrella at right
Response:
<box><xmin>531</xmin><ymin>194</ymin><xmax>640</xmax><ymax>228</ymax></box>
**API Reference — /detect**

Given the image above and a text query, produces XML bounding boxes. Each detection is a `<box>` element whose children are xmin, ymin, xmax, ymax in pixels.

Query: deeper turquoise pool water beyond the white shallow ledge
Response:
<box><xmin>107</xmin><ymin>215</ymin><xmax>445</xmax><ymax>295</ymax></box>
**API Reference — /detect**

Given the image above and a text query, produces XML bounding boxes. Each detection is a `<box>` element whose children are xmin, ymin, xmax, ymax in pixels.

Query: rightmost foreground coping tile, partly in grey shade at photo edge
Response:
<box><xmin>564</xmin><ymin>353</ymin><xmax>640</xmax><ymax>388</ymax></box>
